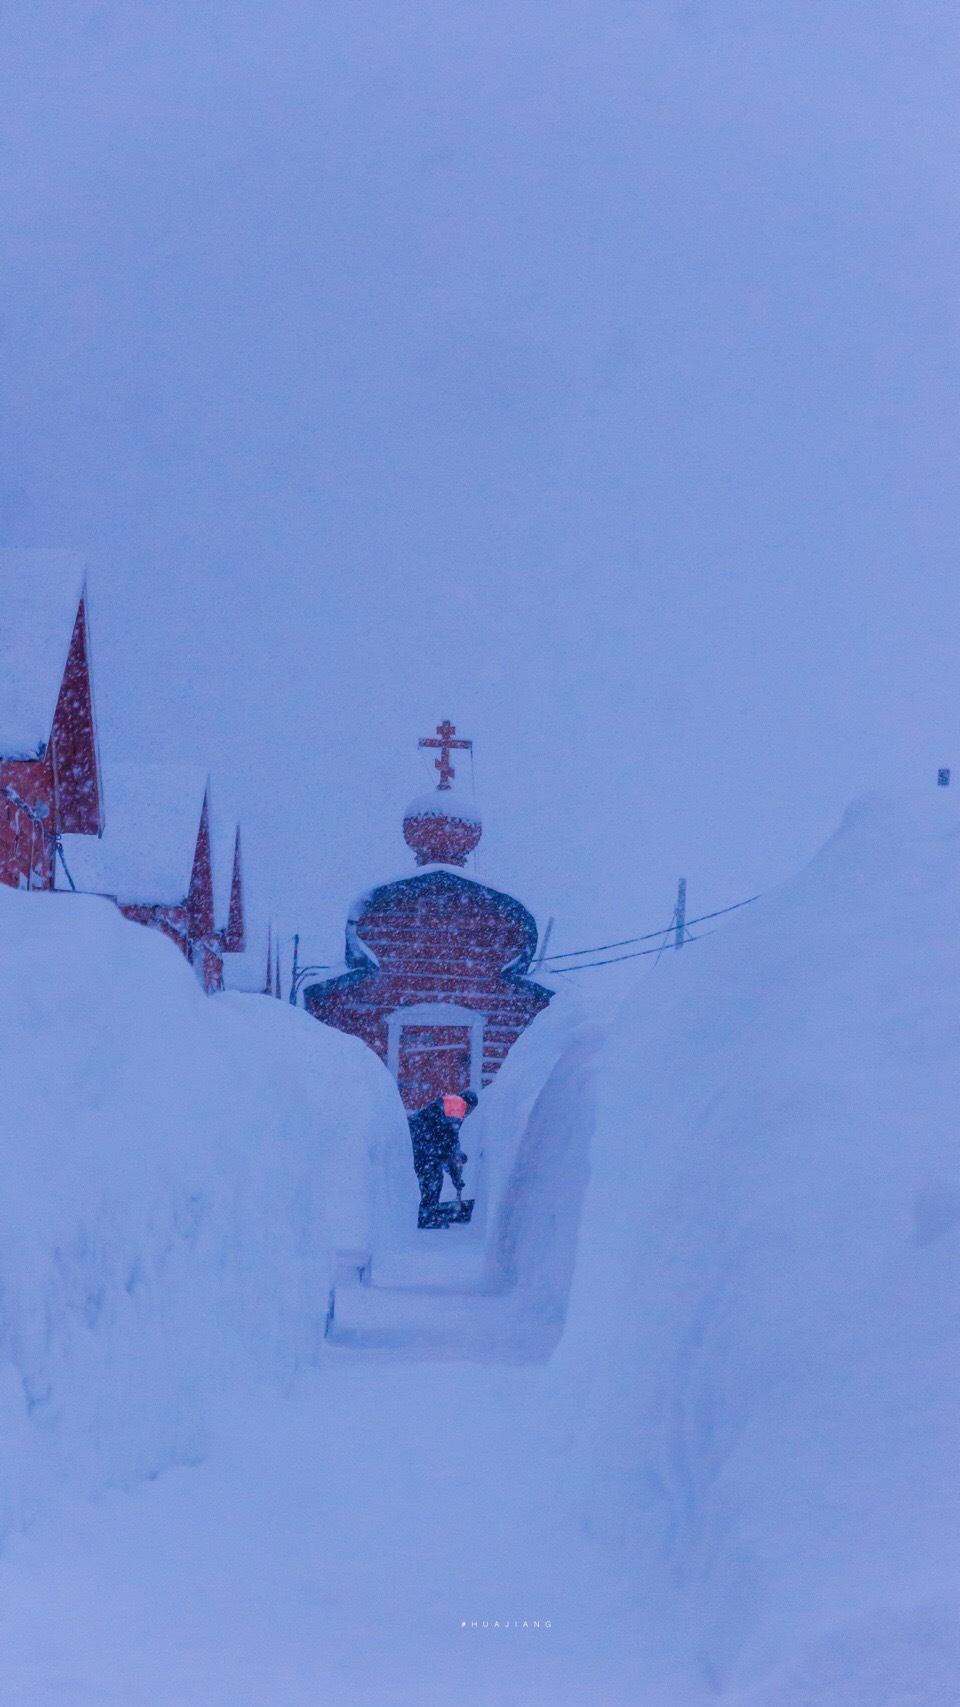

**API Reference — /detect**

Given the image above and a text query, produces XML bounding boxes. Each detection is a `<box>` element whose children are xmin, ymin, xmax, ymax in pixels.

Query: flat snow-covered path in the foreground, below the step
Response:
<box><xmin>0</xmin><ymin>1354</ymin><xmax>655</xmax><ymax>1707</ymax></box>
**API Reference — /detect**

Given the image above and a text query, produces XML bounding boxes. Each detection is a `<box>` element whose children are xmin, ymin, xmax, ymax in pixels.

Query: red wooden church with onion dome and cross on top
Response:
<box><xmin>304</xmin><ymin>722</ymin><xmax>553</xmax><ymax>1113</ymax></box>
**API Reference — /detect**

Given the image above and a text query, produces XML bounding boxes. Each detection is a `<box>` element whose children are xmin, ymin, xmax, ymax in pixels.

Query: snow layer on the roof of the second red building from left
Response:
<box><xmin>58</xmin><ymin>765</ymin><xmax>210</xmax><ymax>905</ymax></box>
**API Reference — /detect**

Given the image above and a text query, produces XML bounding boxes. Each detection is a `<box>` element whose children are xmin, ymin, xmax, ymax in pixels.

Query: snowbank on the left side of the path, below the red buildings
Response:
<box><xmin>0</xmin><ymin>886</ymin><xmax>407</xmax><ymax>1536</ymax></box>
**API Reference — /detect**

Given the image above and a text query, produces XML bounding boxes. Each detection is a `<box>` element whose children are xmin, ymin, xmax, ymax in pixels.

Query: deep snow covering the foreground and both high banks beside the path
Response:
<box><xmin>0</xmin><ymin>797</ymin><xmax>960</xmax><ymax>1707</ymax></box>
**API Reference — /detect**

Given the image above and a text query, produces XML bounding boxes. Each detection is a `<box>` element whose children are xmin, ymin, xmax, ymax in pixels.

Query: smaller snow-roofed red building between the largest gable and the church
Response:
<box><xmin>58</xmin><ymin>765</ymin><xmax>246</xmax><ymax>992</ymax></box>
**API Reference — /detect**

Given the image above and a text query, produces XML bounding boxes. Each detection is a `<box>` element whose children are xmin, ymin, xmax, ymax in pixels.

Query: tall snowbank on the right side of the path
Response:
<box><xmin>552</xmin><ymin>794</ymin><xmax>960</xmax><ymax>1707</ymax></box>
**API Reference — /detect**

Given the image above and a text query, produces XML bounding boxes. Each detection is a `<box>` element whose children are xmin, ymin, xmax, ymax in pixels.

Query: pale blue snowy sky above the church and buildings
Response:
<box><xmin>0</xmin><ymin>0</ymin><xmax>960</xmax><ymax>980</ymax></box>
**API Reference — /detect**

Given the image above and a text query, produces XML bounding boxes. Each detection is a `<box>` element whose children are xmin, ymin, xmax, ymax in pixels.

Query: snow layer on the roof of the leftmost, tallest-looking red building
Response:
<box><xmin>0</xmin><ymin>550</ymin><xmax>85</xmax><ymax>758</ymax></box>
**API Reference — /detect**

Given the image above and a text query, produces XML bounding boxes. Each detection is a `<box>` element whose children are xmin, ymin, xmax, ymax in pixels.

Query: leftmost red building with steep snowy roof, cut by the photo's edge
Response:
<box><xmin>0</xmin><ymin>551</ymin><xmax>102</xmax><ymax>889</ymax></box>
